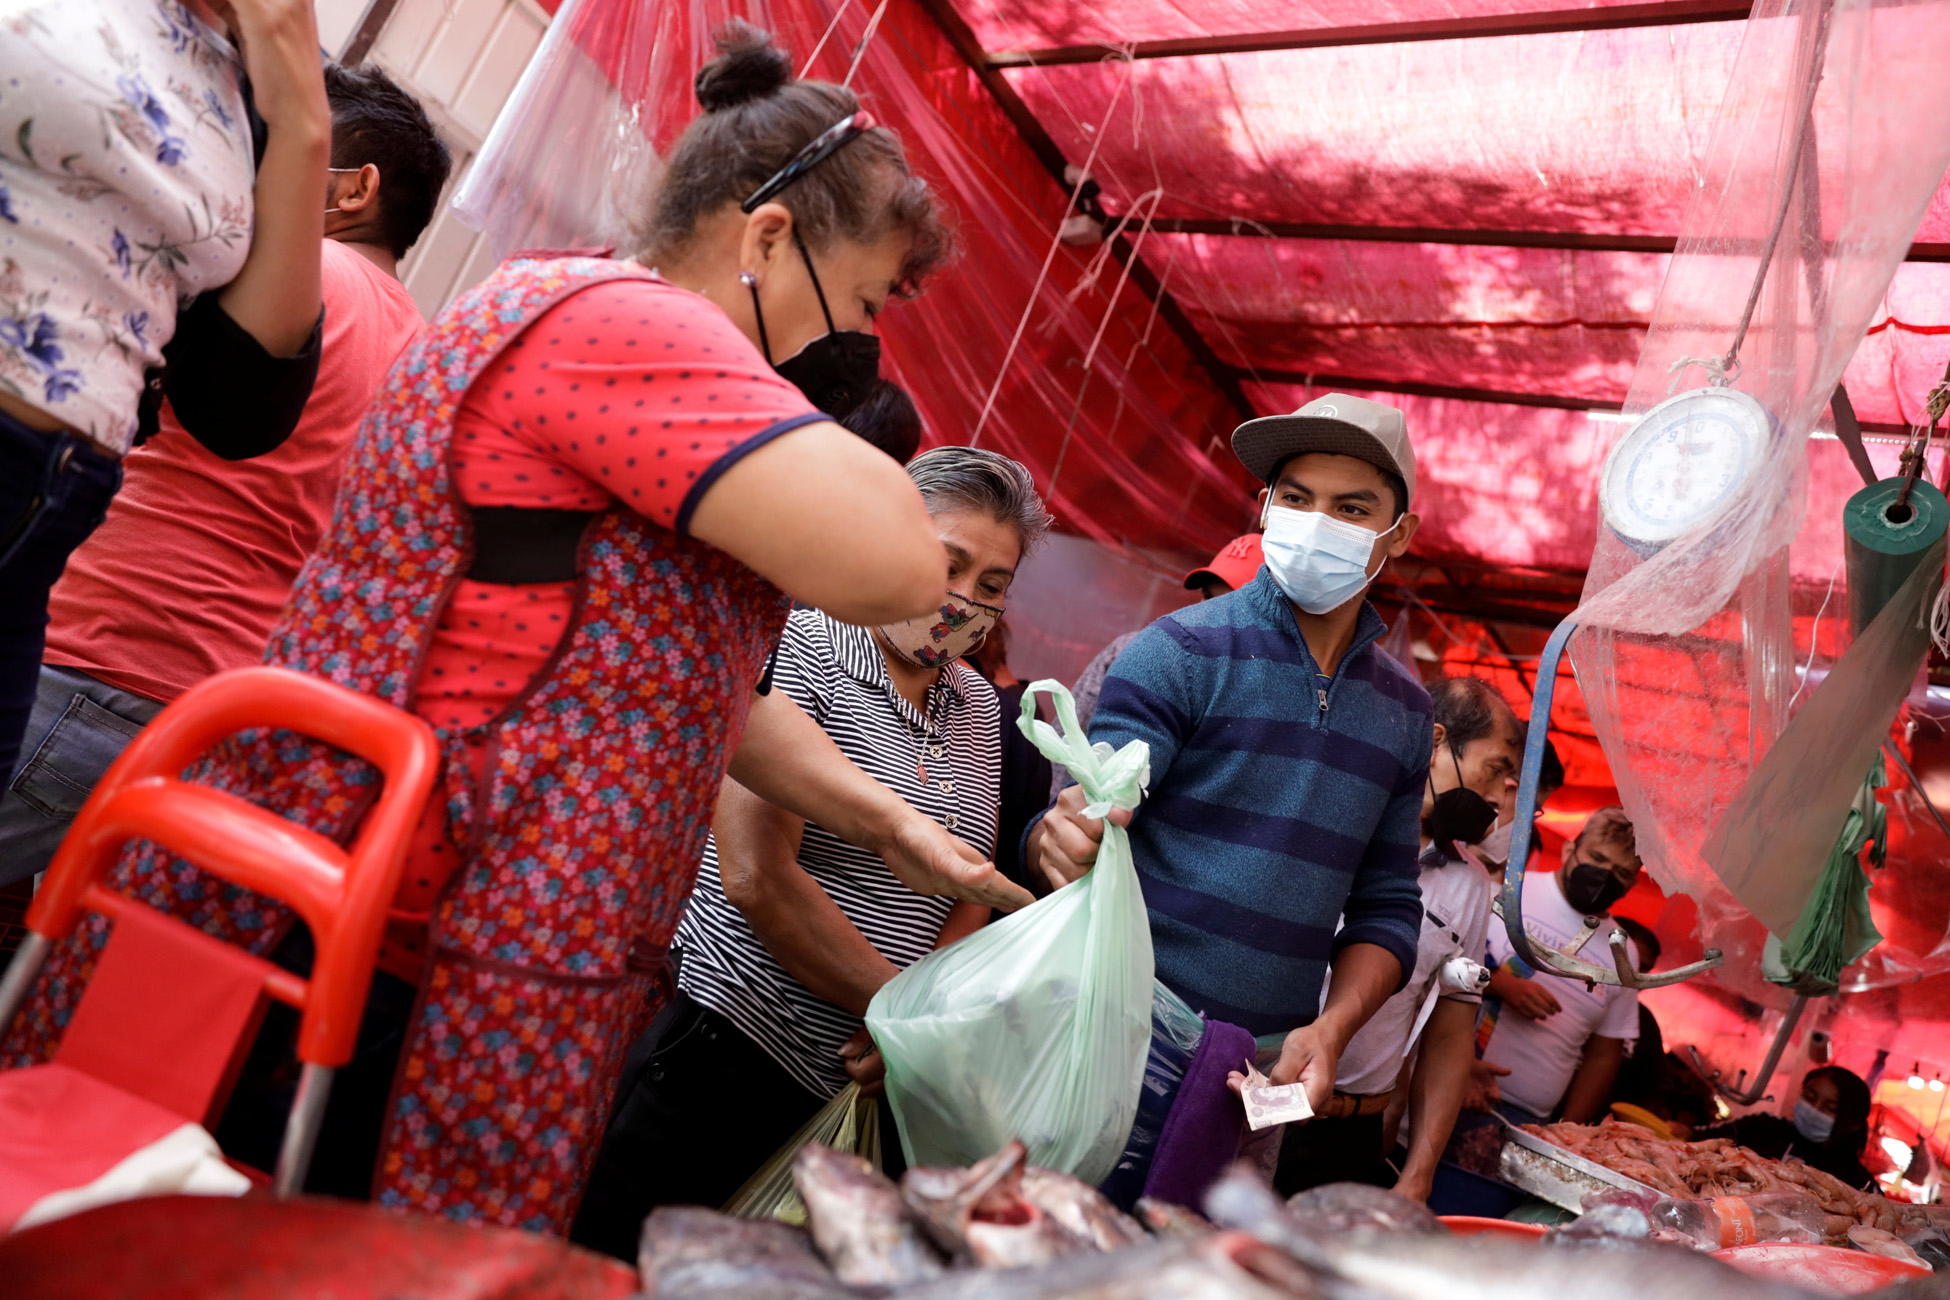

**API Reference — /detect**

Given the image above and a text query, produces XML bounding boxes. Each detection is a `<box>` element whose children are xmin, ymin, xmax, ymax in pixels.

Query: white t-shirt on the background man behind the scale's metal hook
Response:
<box><xmin>1482</xmin><ymin>871</ymin><xmax>1638</xmax><ymax>1115</ymax></box>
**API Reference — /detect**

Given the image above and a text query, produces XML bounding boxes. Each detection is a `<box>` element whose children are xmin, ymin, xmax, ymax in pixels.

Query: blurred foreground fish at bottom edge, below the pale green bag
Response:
<box><xmin>899</xmin><ymin>1232</ymin><xmax>1326</xmax><ymax>1300</ymax></box>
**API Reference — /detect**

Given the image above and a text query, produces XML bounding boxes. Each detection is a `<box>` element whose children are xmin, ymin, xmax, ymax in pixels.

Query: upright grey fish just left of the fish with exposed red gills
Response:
<box><xmin>792</xmin><ymin>1142</ymin><xmax>942</xmax><ymax>1286</ymax></box>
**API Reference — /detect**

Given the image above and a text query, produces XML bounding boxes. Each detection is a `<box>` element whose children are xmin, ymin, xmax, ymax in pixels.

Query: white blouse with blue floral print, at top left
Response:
<box><xmin>0</xmin><ymin>0</ymin><xmax>255</xmax><ymax>452</ymax></box>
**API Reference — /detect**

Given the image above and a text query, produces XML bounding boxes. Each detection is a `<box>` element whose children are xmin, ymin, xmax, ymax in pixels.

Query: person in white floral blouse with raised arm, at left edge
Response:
<box><xmin>0</xmin><ymin>0</ymin><xmax>332</xmax><ymax>772</ymax></box>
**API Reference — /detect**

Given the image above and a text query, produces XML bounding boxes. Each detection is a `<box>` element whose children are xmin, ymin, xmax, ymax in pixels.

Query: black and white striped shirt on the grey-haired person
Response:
<box><xmin>677</xmin><ymin>610</ymin><xmax>1002</xmax><ymax>1097</ymax></box>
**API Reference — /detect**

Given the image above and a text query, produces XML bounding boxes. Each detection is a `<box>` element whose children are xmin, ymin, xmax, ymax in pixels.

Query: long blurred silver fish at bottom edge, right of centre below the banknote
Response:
<box><xmin>1205</xmin><ymin>1169</ymin><xmax>1812</xmax><ymax>1300</ymax></box>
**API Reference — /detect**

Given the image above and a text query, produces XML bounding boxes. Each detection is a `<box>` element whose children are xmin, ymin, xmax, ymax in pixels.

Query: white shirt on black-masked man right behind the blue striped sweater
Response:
<box><xmin>1334</xmin><ymin>846</ymin><xmax>1490</xmax><ymax>1097</ymax></box>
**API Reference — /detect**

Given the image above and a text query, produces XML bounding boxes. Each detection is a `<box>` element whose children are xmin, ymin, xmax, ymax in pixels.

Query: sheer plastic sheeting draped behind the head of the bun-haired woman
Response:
<box><xmin>456</xmin><ymin>0</ymin><xmax>1250</xmax><ymax>573</ymax></box>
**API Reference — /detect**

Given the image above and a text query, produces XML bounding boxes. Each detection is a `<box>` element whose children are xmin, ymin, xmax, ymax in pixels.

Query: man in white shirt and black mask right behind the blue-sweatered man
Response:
<box><xmin>1275</xmin><ymin>676</ymin><xmax>1523</xmax><ymax>1201</ymax></box>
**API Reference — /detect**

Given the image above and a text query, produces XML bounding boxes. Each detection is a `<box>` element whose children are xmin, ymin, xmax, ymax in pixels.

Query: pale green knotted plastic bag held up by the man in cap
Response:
<box><xmin>866</xmin><ymin>680</ymin><xmax>1152</xmax><ymax>1185</ymax></box>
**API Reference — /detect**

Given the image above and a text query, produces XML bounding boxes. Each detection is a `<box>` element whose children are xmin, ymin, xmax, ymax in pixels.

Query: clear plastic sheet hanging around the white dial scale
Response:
<box><xmin>1572</xmin><ymin>0</ymin><xmax>1950</xmax><ymax>955</ymax></box>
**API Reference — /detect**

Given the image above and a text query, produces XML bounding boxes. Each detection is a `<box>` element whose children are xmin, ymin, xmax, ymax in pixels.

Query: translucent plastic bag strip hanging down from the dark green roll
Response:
<box><xmin>1702</xmin><ymin>483</ymin><xmax>1950</xmax><ymax>936</ymax></box>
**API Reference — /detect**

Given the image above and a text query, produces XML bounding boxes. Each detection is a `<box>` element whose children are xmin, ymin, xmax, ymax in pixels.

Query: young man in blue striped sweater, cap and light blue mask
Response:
<box><xmin>1026</xmin><ymin>394</ymin><xmax>1431</xmax><ymax>1109</ymax></box>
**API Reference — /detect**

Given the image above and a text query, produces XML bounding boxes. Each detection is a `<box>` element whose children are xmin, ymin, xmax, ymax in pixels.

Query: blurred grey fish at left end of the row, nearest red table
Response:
<box><xmin>636</xmin><ymin>1204</ymin><xmax>846</xmax><ymax>1300</ymax></box>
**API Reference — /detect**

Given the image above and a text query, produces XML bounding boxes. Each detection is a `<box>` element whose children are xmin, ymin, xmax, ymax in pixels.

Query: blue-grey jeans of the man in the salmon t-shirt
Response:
<box><xmin>0</xmin><ymin>665</ymin><xmax>162</xmax><ymax>887</ymax></box>
